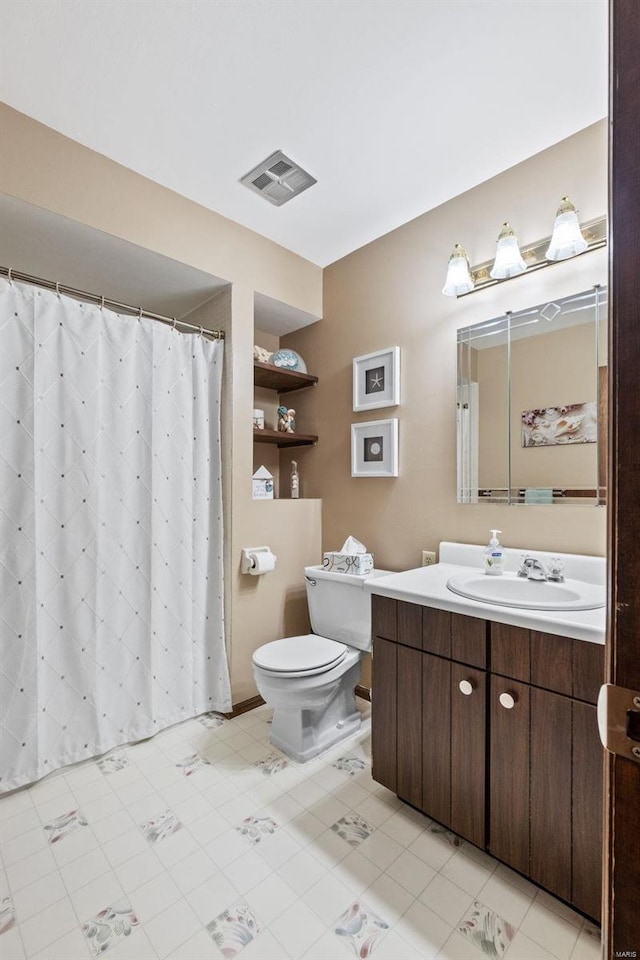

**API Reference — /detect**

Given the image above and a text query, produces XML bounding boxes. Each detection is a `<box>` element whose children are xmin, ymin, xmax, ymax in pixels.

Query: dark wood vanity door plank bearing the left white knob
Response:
<box><xmin>450</xmin><ymin>663</ymin><xmax>487</xmax><ymax>847</ymax></box>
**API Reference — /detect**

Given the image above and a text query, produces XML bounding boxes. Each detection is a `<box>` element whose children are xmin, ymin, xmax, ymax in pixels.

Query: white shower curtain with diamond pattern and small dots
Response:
<box><xmin>0</xmin><ymin>279</ymin><xmax>231</xmax><ymax>792</ymax></box>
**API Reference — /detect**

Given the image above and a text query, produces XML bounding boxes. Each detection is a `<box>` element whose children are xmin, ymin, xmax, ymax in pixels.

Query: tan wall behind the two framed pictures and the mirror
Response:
<box><xmin>283</xmin><ymin>121</ymin><xmax>607</xmax><ymax>569</ymax></box>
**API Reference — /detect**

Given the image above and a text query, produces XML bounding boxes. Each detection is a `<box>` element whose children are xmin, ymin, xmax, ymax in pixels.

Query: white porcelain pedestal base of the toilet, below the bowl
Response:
<box><xmin>269</xmin><ymin>662</ymin><xmax>362</xmax><ymax>763</ymax></box>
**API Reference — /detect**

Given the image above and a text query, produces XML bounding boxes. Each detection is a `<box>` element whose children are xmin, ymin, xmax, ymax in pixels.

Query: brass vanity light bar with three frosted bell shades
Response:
<box><xmin>442</xmin><ymin>197</ymin><xmax>607</xmax><ymax>297</ymax></box>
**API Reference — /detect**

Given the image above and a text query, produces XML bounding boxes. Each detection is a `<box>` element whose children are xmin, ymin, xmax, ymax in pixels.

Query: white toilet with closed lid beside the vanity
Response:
<box><xmin>253</xmin><ymin>566</ymin><xmax>387</xmax><ymax>762</ymax></box>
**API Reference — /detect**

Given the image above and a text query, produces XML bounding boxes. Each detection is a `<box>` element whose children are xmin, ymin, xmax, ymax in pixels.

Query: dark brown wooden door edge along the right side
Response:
<box><xmin>603</xmin><ymin>0</ymin><xmax>640</xmax><ymax>957</ymax></box>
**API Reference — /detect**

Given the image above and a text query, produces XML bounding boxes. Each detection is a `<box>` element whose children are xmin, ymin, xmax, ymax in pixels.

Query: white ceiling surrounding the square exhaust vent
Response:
<box><xmin>0</xmin><ymin>0</ymin><xmax>607</xmax><ymax>266</ymax></box>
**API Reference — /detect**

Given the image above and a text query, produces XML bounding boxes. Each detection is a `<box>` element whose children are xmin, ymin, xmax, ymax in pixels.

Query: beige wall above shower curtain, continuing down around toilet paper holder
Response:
<box><xmin>0</xmin><ymin>105</ymin><xmax>322</xmax><ymax>703</ymax></box>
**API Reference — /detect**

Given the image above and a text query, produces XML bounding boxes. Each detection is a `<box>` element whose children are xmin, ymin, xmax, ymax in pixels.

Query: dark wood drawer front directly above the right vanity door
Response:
<box><xmin>491</xmin><ymin>623</ymin><xmax>604</xmax><ymax>703</ymax></box>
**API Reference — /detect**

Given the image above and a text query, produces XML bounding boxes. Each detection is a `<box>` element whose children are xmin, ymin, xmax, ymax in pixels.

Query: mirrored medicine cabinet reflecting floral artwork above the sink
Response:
<box><xmin>457</xmin><ymin>286</ymin><xmax>607</xmax><ymax>504</ymax></box>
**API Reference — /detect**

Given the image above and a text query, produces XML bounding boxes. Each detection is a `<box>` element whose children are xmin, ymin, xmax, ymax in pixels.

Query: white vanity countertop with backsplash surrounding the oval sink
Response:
<box><xmin>364</xmin><ymin>544</ymin><xmax>606</xmax><ymax>644</ymax></box>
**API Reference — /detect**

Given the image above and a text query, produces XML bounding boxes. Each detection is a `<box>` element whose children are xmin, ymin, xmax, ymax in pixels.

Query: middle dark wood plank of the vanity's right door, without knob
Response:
<box><xmin>529</xmin><ymin>687</ymin><xmax>572</xmax><ymax>900</ymax></box>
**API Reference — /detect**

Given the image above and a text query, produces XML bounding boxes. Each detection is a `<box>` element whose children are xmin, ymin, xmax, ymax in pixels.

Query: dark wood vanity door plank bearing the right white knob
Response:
<box><xmin>488</xmin><ymin>676</ymin><xmax>529</xmax><ymax>874</ymax></box>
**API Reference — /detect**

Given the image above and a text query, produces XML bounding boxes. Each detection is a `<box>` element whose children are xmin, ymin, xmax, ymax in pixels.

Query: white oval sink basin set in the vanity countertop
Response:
<box><xmin>447</xmin><ymin>573</ymin><xmax>606</xmax><ymax>610</ymax></box>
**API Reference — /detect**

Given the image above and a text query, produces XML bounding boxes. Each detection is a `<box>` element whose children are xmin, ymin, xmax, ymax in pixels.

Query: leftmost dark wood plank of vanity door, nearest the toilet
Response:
<box><xmin>371</xmin><ymin>637</ymin><xmax>398</xmax><ymax>793</ymax></box>
